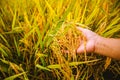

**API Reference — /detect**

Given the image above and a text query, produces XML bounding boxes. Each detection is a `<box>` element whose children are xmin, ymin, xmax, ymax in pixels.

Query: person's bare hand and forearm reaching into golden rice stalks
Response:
<box><xmin>77</xmin><ymin>27</ymin><xmax>120</xmax><ymax>60</ymax></box>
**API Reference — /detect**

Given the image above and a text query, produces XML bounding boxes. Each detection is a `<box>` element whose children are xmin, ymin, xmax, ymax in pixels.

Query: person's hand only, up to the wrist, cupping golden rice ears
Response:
<box><xmin>77</xmin><ymin>27</ymin><xmax>99</xmax><ymax>53</ymax></box>
